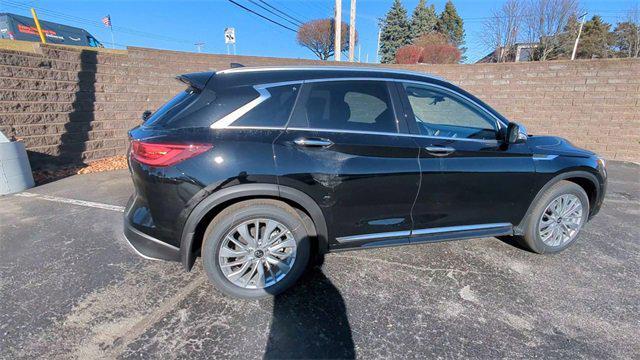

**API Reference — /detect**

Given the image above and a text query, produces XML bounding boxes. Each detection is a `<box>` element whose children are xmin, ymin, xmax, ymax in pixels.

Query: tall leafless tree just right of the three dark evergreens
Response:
<box><xmin>482</xmin><ymin>0</ymin><xmax>524</xmax><ymax>62</ymax></box>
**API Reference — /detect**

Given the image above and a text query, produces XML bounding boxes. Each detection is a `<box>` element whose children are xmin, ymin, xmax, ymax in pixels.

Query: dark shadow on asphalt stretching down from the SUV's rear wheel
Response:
<box><xmin>264</xmin><ymin>260</ymin><xmax>355</xmax><ymax>359</ymax></box>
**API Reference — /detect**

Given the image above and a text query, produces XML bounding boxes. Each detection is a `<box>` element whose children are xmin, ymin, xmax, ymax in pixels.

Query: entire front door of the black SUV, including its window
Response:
<box><xmin>398</xmin><ymin>83</ymin><xmax>535</xmax><ymax>230</ymax></box>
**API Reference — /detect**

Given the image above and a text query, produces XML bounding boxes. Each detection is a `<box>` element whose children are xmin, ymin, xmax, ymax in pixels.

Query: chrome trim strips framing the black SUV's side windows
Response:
<box><xmin>211</xmin><ymin>76</ymin><xmax>507</xmax><ymax>136</ymax></box>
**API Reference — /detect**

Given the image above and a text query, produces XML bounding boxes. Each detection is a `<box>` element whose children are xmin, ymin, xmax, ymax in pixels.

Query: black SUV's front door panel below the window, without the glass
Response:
<box><xmin>439</xmin><ymin>140</ymin><xmax>534</xmax><ymax>226</ymax></box>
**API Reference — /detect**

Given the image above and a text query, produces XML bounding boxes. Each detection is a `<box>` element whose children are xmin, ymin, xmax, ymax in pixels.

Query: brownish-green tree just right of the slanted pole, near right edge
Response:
<box><xmin>576</xmin><ymin>15</ymin><xmax>613</xmax><ymax>59</ymax></box>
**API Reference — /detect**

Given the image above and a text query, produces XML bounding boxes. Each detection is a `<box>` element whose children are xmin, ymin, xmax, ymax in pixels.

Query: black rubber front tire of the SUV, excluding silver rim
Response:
<box><xmin>521</xmin><ymin>180</ymin><xmax>589</xmax><ymax>254</ymax></box>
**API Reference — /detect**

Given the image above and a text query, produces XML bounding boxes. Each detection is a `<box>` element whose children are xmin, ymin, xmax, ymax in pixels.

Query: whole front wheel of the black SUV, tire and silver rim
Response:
<box><xmin>522</xmin><ymin>180</ymin><xmax>589</xmax><ymax>254</ymax></box>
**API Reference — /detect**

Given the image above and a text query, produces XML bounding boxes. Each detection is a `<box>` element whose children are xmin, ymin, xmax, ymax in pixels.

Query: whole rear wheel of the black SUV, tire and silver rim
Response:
<box><xmin>201</xmin><ymin>199</ymin><xmax>311</xmax><ymax>299</ymax></box>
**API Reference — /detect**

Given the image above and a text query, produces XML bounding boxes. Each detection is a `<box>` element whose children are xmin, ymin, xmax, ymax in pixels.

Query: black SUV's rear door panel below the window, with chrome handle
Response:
<box><xmin>274</xmin><ymin>129</ymin><xmax>419</xmax><ymax>248</ymax></box>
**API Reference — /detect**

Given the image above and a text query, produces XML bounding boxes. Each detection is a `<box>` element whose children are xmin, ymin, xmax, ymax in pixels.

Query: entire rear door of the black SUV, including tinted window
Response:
<box><xmin>274</xmin><ymin>81</ymin><xmax>420</xmax><ymax>249</ymax></box>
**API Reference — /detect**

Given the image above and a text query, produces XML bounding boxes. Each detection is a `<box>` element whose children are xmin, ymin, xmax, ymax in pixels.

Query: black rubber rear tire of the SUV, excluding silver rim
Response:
<box><xmin>201</xmin><ymin>199</ymin><xmax>310</xmax><ymax>299</ymax></box>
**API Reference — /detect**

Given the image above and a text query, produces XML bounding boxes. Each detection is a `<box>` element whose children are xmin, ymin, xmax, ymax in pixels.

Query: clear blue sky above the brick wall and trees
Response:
<box><xmin>0</xmin><ymin>0</ymin><xmax>639</xmax><ymax>62</ymax></box>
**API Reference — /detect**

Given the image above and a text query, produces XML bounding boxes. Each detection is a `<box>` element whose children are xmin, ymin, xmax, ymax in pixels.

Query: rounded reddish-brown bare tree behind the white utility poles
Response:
<box><xmin>296</xmin><ymin>19</ymin><xmax>358</xmax><ymax>60</ymax></box>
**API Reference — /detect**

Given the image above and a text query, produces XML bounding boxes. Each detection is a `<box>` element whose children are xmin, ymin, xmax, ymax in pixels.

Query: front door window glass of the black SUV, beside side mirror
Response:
<box><xmin>403</xmin><ymin>83</ymin><xmax>498</xmax><ymax>140</ymax></box>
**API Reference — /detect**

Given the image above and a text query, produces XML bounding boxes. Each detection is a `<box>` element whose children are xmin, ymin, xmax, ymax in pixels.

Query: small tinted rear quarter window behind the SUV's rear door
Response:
<box><xmin>231</xmin><ymin>85</ymin><xmax>299</xmax><ymax>127</ymax></box>
